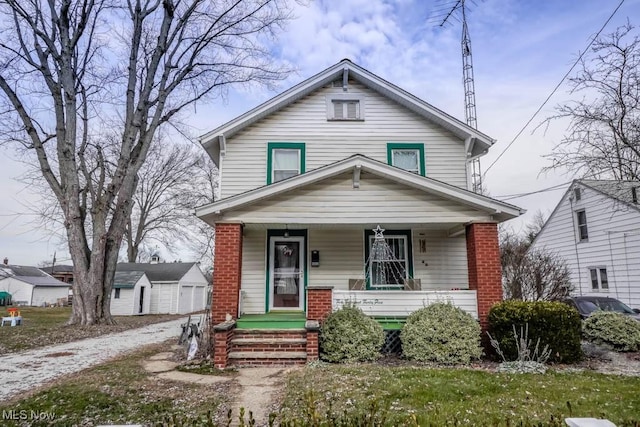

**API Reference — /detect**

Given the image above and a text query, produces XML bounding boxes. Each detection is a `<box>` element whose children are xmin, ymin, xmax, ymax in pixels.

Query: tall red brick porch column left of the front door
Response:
<box><xmin>211</xmin><ymin>224</ymin><xmax>242</xmax><ymax>325</ymax></box>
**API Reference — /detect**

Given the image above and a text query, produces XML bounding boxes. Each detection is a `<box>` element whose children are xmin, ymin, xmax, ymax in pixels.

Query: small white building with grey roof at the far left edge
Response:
<box><xmin>0</xmin><ymin>264</ymin><xmax>69</xmax><ymax>306</ymax></box>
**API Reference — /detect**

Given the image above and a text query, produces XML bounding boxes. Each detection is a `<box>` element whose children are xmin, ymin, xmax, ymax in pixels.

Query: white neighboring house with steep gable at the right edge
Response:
<box><xmin>532</xmin><ymin>180</ymin><xmax>640</xmax><ymax>308</ymax></box>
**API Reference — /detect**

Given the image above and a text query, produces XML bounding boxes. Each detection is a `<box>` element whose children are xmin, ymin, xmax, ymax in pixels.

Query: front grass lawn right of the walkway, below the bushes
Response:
<box><xmin>283</xmin><ymin>364</ymin><xmax>640</xmax><ymax>426</ymax></box>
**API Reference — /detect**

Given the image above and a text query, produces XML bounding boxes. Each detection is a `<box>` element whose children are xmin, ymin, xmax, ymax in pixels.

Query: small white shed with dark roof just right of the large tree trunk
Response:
<box><xmin>111</xmin><ymin>271</ymin><xmax>151</xmax><ymax>316</ymax></box>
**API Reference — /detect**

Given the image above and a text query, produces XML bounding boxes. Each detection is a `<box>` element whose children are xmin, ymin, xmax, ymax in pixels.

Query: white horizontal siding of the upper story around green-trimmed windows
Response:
<box><xmin>221</xmin><ymin>82</ymin><xmax>467</xmax><ymax>198</ymax></box>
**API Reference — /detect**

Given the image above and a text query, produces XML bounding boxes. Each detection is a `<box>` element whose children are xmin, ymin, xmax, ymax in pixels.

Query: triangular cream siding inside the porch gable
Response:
<box><xmin>219</xmin><ymin>172</ymin><xmax>491</xmax><ymax>224</ymax></box>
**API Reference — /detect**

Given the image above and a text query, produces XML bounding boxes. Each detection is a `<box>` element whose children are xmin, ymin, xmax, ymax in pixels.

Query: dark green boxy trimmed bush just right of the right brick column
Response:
<box><xmin>488</xmin><ymin>301</ymin><xmax>582</xmax><ymax>363</ymax></box>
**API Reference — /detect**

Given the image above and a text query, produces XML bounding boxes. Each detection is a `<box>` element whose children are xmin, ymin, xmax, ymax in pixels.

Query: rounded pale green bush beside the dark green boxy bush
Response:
<box><xmin>400</xmin><ymin>303</ymin><xmax>482</xmax><ymax>364</ymax></box>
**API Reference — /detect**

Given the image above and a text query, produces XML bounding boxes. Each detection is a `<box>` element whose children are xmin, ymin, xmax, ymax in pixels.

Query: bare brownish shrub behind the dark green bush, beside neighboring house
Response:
<box><xmin>500</xmin><ymin>230</ymin><xmax>572</xmax><ymax>301</ymax></box>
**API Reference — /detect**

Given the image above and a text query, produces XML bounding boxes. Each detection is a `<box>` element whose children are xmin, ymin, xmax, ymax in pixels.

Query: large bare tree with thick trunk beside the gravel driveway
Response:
<box><xmin>0</xmin><ymin>0</ymin><xmax>289</xmax><ymax>324</ymax></box>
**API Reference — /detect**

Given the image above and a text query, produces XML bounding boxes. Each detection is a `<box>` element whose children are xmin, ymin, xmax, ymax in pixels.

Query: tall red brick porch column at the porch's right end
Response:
<box><xmin>466</xmin><ymin>223</ymin><xmax>502</xmax><ymax>336</ymax></box>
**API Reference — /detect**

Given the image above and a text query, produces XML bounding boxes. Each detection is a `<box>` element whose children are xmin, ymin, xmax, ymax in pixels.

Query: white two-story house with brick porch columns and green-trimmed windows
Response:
<box><xmin>196</xmin><ymin>60</ymin><xmax>522</xmax><ymax>366</ymax></box>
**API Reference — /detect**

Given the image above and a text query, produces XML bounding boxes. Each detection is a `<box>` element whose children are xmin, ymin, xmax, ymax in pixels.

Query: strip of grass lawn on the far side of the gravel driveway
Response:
<box><xmin>0</xmin><ymin>307</ymin><xmax>184</xmax><ymax>355</ymax></box>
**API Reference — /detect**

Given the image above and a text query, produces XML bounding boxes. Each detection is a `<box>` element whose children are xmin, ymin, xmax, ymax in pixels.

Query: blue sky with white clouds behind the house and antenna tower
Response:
<box><xmin>0</xmin><ymin>0</ymin><xmax>640</xmax><ymax>264</ymax></box>
